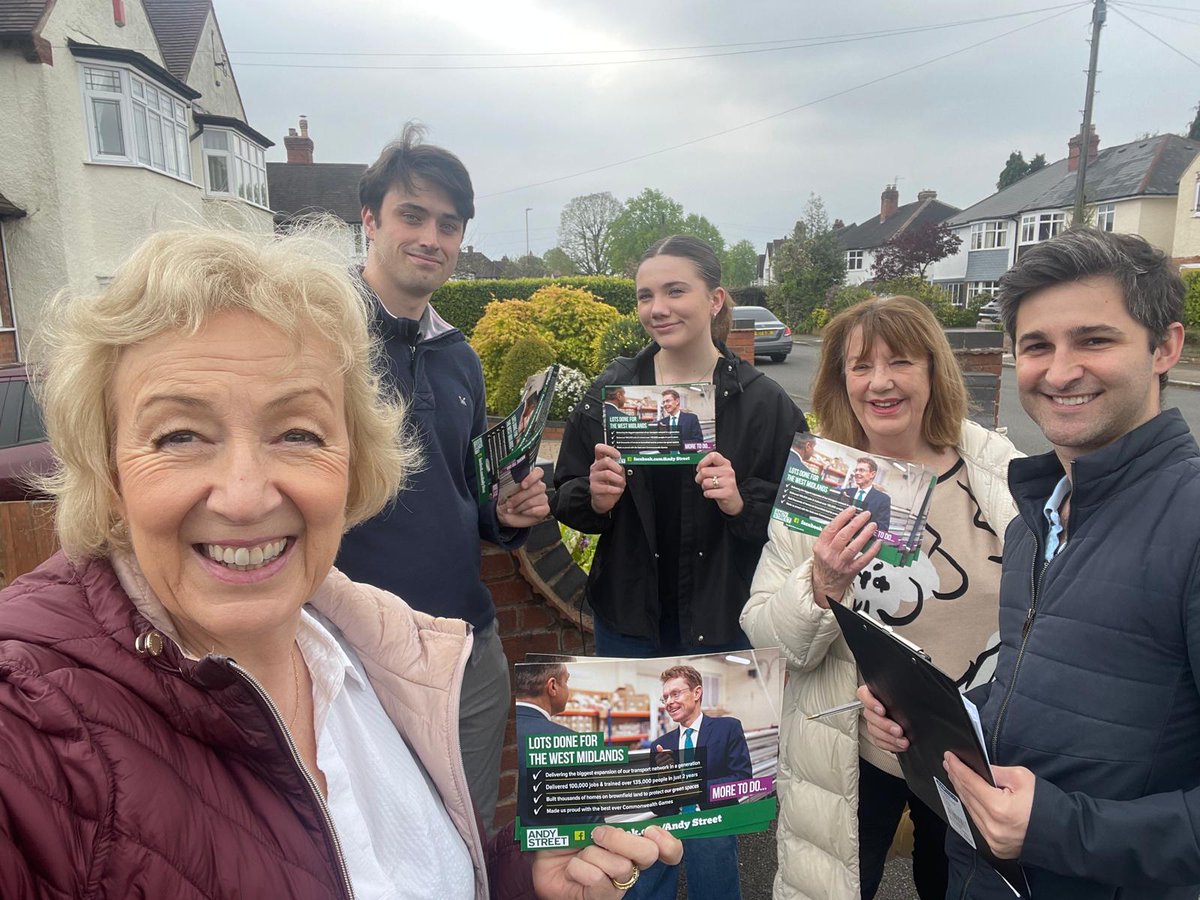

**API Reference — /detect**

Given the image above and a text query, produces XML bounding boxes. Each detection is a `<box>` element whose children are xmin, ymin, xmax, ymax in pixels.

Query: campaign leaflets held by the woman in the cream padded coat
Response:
<box><xmin>770</xmin><ymin>432</ymin><xmax>937</xmax><ymax>566</ymax></box>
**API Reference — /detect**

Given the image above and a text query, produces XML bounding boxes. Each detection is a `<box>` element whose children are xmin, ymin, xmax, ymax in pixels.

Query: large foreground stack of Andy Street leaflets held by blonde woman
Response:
<box><xmin>515</xmin><ymin>648</ymin><xmax>784</xmax><ymax>850</ymax></box>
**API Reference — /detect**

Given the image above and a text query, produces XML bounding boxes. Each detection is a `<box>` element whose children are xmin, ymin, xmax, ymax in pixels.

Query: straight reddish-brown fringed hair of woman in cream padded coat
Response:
<box><xmin>812</xmin><ymin>296</ymin><xmax>967</xmax><ymax>450</ymax></box>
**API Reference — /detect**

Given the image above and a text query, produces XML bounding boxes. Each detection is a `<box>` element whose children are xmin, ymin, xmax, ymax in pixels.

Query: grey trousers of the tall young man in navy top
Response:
<box><xmin>458</xmin><ymin>619</ymin><xmax>511</xmax><ymax>836</ymax></box>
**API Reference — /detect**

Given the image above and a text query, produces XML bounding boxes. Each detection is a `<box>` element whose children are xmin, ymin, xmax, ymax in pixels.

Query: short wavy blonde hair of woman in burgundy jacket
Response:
<box><xmin>30</xmin><ymin>223</ymin><xmax>420</xmax><ymax>559</ymax></box>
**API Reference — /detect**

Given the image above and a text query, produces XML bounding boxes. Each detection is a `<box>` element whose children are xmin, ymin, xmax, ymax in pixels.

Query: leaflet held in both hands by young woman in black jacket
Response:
<box><xmin>604</xmin><ymin>382</ymin><xmax>716</xmax><ymax>466</ymax></box>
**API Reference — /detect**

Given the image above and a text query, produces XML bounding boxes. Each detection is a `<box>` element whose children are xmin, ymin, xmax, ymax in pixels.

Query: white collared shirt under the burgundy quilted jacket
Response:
<box><xmin>296</xmin><ymin>610</ymin><xmax>475</xmax><ymax>900</ymax></box>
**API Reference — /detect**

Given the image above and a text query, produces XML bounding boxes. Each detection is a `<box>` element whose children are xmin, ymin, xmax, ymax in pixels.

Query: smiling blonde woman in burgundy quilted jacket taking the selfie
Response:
<box><xmin>0</xmin><ymin>234</ymin><xmax>680</xmax><ymax>900</ymax></box>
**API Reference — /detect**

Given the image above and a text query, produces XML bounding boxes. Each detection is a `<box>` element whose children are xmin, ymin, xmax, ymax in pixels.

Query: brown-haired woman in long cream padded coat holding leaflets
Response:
<box><xmin>742</xmin><ymin>296</ymin><xmax>1019</xmax><ymax>900</ymax></box>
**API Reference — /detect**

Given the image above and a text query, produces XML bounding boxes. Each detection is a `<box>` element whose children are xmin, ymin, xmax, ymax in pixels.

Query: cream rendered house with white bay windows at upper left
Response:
<box><xmin>0</xmin><ymin>0</ymin><xmax>272</xmax><ymax>360</ymax></box>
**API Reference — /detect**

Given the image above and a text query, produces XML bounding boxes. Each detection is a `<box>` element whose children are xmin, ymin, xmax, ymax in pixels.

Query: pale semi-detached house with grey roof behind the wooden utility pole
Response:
<box><xmin>929</xmin><ymin>131</ymin><xmax>1200</xmax><ymax>305</ymax></box>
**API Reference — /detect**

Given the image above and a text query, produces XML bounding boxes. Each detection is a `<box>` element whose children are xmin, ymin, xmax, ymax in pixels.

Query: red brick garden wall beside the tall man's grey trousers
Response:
<box><xmin>481</xmin><ymin>542</ymin><xmax>590</xmax><ymax>826</ymax></box>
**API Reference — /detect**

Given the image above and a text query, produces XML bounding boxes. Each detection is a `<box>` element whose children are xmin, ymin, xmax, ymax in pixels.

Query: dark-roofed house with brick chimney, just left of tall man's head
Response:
<box><xmin>266</xmin><ymin>115</ymin><xmax>367</xmax><ymax>265</ymax></box>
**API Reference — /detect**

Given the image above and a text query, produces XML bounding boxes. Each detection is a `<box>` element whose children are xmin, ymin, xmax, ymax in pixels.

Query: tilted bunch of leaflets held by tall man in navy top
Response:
<box><xmin>472</xmin><ymin>362</ymin><xmax>558</xmax><ymax>503</ymax></box>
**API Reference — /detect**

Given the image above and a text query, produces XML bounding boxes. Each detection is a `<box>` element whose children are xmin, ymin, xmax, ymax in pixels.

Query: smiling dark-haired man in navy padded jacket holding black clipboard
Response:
<box><xmin>864</xmin><ymin>229</ymin><xmax>1200</xmax><ymax>900</ymax></box>
